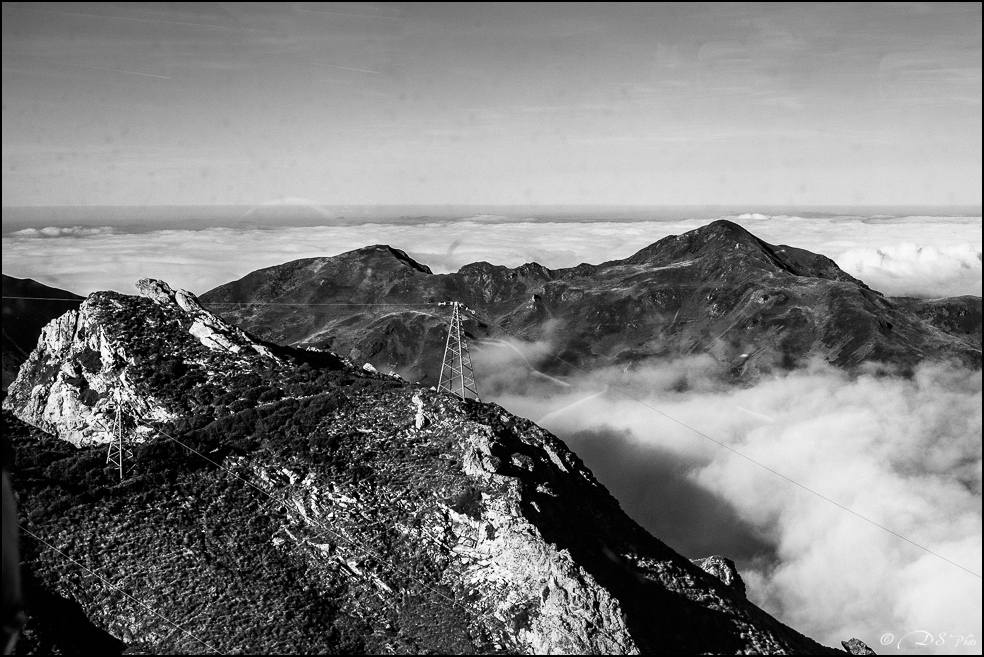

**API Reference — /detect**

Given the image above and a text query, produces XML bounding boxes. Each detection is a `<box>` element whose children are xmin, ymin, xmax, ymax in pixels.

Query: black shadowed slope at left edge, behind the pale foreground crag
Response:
<box><xmin>3</xmin><ymin>274</ymin><xmax>82</xmax><ymax>390</ymax></box>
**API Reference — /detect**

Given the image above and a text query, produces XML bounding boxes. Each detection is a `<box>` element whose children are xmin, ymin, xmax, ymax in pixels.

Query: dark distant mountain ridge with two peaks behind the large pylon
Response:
<box><xmin>202</xmin><ymin>221</ymin><xmax>981</xmax><ymax>383</ymax></box>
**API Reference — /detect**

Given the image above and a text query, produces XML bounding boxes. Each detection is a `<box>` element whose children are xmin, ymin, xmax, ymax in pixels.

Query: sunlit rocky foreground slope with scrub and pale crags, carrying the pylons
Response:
<box><xmin>4</xmin><ymin>281</ymin><xmax>868</xmax><ymax>654</ymax></box>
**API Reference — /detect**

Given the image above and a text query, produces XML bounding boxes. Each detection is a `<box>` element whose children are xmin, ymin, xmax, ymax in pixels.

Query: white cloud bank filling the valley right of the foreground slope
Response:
<box><xmin>473</xmin><ymin>343</ymin><xmax>982</xmax><ymax>654</ymax></box>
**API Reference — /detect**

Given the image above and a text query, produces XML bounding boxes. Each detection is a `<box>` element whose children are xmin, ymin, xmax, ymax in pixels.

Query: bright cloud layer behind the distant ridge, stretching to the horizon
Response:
<box><xmin>3</xmin><ymin>213</ymin><xmax>981</xmax><ymax>297</ymax></box>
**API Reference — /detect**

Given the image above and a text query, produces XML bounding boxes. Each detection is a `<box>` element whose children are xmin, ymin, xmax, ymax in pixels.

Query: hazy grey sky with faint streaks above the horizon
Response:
<box><xmin>3</xmin><ymin>3</ymin><xmax>981</xmax><ymax>206</ymax></box>
